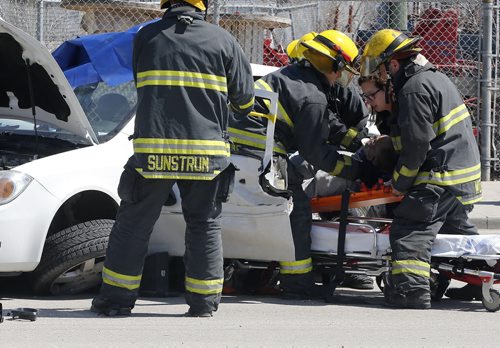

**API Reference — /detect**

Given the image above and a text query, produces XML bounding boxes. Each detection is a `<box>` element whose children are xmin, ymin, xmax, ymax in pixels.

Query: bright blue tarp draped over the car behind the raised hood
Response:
<box><xmin>52</xmin><ymin>20</ymin><xmax>156</xmax><ymax>88</ymax></box>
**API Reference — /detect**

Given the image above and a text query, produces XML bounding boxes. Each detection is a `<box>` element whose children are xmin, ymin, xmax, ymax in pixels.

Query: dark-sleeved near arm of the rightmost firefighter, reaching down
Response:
<box><xmin>392</xmin><ymin>93</ymin><xmax>435</xmax><ymax>193</ymax></box>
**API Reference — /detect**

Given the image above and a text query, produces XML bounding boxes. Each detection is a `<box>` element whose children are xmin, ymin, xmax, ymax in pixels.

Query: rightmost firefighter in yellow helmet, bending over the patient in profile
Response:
<box><xmin>361</xmin><ymin>29</ymin><xmax>481</xmax><ymax>309</ymax></box>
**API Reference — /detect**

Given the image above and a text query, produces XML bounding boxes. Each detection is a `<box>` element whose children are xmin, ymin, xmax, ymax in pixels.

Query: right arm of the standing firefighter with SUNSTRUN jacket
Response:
<box><xmin>226</xmin><ymin>40</ymin><xmax>254</xmax><ymax>115</ymax></box>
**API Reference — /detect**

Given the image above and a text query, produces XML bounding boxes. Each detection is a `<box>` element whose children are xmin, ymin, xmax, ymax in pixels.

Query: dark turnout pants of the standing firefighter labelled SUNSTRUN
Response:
<box><xmin>101</xmin><ymin>161</ymin><xmax>234</xmax><ymax>311</ymax></box>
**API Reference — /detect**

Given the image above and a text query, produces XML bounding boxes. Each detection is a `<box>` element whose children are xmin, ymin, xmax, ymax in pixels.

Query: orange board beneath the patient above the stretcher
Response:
<box><xmin>311</xmin><ymin>187</ymin><xmax>403</xmax><ymax>213</ymax></box>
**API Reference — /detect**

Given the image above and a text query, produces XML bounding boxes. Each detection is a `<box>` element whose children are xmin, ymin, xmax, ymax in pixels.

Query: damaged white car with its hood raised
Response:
<box><xmin>0</xmin><ymin>19</ymin><xmax>293</xmax><ymax>294</ymax></box>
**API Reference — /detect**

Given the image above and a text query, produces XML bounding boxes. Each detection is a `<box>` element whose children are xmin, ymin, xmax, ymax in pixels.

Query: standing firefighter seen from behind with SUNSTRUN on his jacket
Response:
<box><xmin>91</xmin><ymin>0</ymin><xmax>254</xmax><ymax>317</ymax></box>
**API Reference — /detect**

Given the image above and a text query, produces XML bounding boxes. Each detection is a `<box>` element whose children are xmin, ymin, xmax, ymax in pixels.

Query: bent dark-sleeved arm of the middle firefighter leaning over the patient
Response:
<box><xmin>294</xmin><ymin>103</ymin><xmax>357</xmax><ymax>179</ymax></box>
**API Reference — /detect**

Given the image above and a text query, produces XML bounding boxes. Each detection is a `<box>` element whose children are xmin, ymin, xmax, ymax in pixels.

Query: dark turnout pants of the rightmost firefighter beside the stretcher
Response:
<box><xmin>388</xmin><ymin>184</ymin><xmax>477</xmax><ymax>297</ymax></box>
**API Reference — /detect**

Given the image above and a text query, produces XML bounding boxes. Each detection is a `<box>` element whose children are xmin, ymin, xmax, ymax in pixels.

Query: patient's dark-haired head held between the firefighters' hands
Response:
<box><xmin>363</xmin><ymin>135</ymin><xmax>398</xmax><ymax>173</ymax></box>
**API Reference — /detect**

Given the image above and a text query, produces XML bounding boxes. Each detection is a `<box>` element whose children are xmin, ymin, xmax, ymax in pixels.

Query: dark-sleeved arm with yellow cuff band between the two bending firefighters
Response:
<box><xmin>329</xmin><ymin>86</ymin><xmax>369</xmax><ymax>152</ymax></box>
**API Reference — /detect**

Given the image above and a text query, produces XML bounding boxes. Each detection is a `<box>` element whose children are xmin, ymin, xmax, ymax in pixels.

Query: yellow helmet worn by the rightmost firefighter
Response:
<box><xmin>360</xmin><ymin>29</ymin><xmax>422</xmax><ymax>76</ymax></box>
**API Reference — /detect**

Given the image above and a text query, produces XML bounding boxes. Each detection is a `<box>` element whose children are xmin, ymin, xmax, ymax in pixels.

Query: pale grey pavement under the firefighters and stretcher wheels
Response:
<box><xmin>0</xmin><ymin>182</ymin><xmax>500</xmax><ymax>347</ymax></box>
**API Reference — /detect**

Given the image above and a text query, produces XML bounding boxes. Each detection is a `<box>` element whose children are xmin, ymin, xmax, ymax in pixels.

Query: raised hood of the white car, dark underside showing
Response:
<box><xmin>0</xmin><ymin>18</ymin><xmax>98</xmax><ymax>144</ymax></box>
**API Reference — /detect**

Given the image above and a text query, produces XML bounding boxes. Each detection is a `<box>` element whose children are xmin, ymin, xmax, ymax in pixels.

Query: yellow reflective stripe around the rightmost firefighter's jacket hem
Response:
<box><xmin>415</xmin><ymin>164</ymin><xmax>481</xmax><ymax>186</ymax></box>
